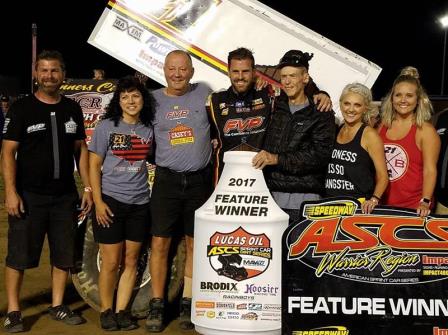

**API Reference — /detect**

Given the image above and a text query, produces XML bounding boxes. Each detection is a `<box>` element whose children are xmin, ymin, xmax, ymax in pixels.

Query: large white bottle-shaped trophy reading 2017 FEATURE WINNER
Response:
<box><xmin>191</xmin><ymin>151</ymin><xmax>288</xmax><ymax>335</ymax></box>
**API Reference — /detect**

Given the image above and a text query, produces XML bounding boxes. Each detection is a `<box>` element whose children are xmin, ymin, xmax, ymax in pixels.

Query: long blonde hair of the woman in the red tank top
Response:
<box><xmin>381</xmin><ymin>66</ymin><xmax>433</xmax><ymax>128</ymax></box>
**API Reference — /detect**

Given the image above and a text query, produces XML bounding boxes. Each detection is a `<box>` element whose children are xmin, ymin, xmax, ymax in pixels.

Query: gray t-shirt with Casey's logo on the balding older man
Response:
<box><xmin>152</xmin><ymin>83</ymin><xmax>212</xmax><ymax>172</ymax></box>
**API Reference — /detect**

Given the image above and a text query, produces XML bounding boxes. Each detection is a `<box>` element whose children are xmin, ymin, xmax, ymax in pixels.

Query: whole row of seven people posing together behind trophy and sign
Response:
<box><xmin>2</xmin><ymin>48</ymin><xmax>446</xmax><ymax>332</ymax></box>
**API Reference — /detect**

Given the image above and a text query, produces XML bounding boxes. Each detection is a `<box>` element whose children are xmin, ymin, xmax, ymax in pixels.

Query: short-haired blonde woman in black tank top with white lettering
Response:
<box><xmin>325</xmin><ymin>83</ymin><xmax>388</xmax><ymax>213</ymax></box>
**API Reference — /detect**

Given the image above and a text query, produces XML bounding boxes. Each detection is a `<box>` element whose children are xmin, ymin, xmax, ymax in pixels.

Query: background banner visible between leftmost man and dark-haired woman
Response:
<box><xmin>60</xmin><ymin>79</ymin><xmax>117</xmax><ymax>144</ymax></box>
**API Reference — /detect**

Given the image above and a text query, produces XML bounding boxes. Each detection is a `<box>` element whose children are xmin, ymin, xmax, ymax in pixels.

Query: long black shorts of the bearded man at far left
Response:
<box><xmin>6</xmin><ymin>192</ymin><xmax>78</xmax><ymax>270</ymax></box>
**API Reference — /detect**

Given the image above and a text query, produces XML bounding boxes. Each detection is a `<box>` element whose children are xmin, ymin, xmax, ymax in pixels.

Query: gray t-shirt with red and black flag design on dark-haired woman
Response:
<box><xmin>89</xmin><ymin>119</ymin><xmax>153</xmax><ymax>205</ymax></box>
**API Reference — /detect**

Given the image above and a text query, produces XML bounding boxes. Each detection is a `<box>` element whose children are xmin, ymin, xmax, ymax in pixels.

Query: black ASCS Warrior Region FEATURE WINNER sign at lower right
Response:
<box><xmin>282</xmin><ymin>198</ymin><xmax>448</xmax><ymax>335</ymax></box>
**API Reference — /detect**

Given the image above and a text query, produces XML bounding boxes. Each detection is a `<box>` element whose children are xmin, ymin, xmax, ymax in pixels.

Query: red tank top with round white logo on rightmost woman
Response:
<box><xmin>380</xmin><ymin>125</ymin><xmax>423</xmax><ymax>209</ymax></box>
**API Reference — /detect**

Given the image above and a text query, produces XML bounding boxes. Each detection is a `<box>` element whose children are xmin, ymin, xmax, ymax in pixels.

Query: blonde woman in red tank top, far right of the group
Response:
<box><xmin>379</xmin><ymin>68</ymin><xmax>440</xmax><ymax>216</ymax></box>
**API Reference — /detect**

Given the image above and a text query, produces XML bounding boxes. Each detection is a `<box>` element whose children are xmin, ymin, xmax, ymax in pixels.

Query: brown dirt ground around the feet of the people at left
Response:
<box><xmin>0</xmin><ymin>182</ymin><xmax>198</xmax><ymax>335</ymax></box>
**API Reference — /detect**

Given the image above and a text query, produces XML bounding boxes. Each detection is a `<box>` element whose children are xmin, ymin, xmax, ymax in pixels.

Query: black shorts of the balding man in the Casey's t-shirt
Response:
<box><xmin>151</xmin><ymin>166</ymin><xmax>213</xmax><ymax>237</ymax></box>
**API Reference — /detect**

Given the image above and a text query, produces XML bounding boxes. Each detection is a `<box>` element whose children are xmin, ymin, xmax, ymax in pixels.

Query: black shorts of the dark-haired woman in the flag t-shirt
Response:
<box><xmin>92</xmin><ymin>194</ymin><xmax>150</xmax><ymax>244</ymax></box>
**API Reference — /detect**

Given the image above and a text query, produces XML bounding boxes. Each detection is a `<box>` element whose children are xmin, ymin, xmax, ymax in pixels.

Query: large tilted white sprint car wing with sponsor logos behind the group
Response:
<box><xmin>88</xmin><ymin>0</ymin><xmax>381</xmax><ymax>114</ymax></box>
